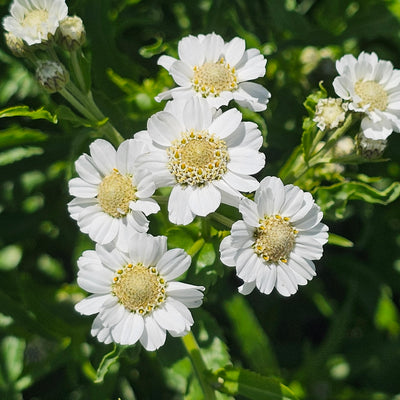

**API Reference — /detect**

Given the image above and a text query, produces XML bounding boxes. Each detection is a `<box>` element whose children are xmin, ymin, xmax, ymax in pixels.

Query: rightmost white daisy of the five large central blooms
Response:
<box><xmin>220</xmin><ymin>176</ymin><xmax>328</xmax><ymax>296</ymax></box>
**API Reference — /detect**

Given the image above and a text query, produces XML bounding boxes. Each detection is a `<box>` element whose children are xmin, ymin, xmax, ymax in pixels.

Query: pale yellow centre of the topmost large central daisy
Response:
<box><xmin>192</xmin><ymin>58</ymin><xmax>237</xmax><ymax>97</ymax></box>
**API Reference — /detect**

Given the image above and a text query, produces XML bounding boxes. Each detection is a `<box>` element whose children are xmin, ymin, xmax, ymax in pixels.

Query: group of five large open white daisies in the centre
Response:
<box><xmin>63</xmin><ymin>33</ymin><xmax>328</xmax><ymax>350</ymax></box>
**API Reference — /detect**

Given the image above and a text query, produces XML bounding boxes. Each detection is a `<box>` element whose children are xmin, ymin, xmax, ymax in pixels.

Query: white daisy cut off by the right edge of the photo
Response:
<box><xmin>333</xmin><ymin>52</ymin><xmax>400</xmax><ymax>140</ymax></box>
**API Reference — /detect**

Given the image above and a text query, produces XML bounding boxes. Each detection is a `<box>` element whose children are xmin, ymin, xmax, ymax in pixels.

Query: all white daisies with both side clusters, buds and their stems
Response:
<box><xmin>14</xmin><ymin>0</ymin><xmax>400</xmax><ymax>351</ymax></box>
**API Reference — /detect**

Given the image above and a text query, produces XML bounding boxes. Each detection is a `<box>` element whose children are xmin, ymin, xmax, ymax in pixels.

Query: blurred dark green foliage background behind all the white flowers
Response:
<box><xmin>0</xmin><ymin>0</ymin><xmax>400</xmax><ymax>400</ymax></box>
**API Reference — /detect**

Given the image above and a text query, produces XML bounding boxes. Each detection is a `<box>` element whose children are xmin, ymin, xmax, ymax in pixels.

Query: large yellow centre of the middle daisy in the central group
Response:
<box><xmin>167</xmin><ymin>130</ymin><xmax>229</xmax><ymax>185</ymax></box>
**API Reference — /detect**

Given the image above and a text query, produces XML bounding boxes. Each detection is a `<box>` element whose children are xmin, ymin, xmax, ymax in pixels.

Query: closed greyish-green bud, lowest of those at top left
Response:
<box><xmin>36</xmin><ymin>61</ymin><xmax>69</xmax><ymax>93</ymax></box>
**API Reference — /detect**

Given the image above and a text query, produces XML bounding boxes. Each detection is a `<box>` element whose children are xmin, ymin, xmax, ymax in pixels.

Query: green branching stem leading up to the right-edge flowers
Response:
<box><xmin>284</xmin><ymin>114</ymin><xmax>353</xmax><ymax>183</ymax></box>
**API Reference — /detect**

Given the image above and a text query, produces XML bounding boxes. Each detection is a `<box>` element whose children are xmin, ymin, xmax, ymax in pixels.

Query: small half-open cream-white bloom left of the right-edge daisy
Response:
<box><xmin>313</xmin><ymin>97</ymin><xmax>348</xmax><ymax>131</ymax></box>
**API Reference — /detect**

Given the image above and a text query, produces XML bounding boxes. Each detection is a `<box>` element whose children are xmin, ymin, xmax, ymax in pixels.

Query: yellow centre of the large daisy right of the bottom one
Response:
<box><xmin>253</xmin><ymin>215</ymin><xmax>298</xmax><ymax>263</ymax></box>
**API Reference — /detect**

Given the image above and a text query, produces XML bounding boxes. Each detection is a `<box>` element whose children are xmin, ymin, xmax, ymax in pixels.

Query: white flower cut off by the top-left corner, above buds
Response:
<box><xmin>3</xmin><ymin>0</ymin><xmax>68</xmax><ymax>46</ymax></box>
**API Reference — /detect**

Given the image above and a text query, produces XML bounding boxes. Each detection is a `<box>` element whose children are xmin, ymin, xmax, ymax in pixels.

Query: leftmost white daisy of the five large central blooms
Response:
<box><xmin>68</xmin><ymin>139</ymin><xmax>160</xmax><ymax>251</ymax></box>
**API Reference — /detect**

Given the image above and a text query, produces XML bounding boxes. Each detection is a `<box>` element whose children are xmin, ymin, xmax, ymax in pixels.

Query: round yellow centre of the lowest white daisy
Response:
<box><xmin>112</xmin><ymin>264</ymin><xmax>167</xmax><ymax>315</ymax></box>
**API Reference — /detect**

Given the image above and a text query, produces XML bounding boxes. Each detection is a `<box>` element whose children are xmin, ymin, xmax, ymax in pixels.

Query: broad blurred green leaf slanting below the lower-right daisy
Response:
<box><xmin>224</xmin><ymin>295</ymin><xmax>278</xmax><ymax>374</ymax></box>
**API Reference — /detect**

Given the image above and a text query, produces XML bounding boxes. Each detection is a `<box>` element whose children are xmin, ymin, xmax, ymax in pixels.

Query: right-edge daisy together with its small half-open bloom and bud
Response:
<box><xmin>314</xmin><ymin>52</ymin><xmax>400</xmax><ymax>158</ymax></box>
